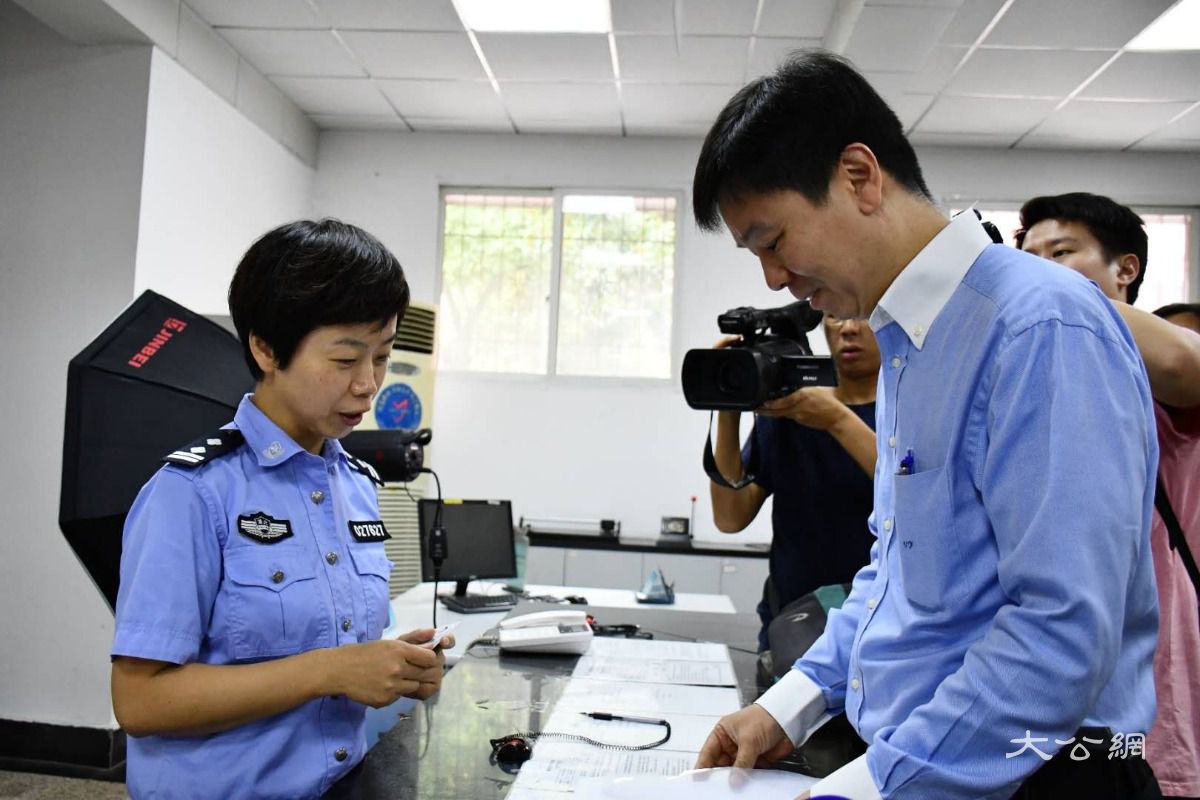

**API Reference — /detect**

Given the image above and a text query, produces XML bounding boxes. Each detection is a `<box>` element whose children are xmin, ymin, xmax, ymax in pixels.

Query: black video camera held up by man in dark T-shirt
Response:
<box><xmin>683</xmin><ymin>300</ymin><xmax>838</xmax><ymax>411</ymax></box>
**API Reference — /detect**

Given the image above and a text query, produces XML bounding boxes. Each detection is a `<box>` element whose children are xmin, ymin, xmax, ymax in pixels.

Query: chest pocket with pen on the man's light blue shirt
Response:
<box><xmin>894</xmin><ymin>467</ymin><xmax>962</xmax><ymax>612</ymax></box>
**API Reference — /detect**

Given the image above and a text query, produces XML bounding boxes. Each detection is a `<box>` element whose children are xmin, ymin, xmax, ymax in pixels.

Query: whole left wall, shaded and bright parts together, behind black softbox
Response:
<box><xmin>0</xmin><ymin>0</ymin><xmax>313</xmax><ymax>728</ymax></box>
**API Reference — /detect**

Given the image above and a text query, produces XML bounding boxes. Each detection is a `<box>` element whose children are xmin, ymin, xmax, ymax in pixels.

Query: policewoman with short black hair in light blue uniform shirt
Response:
<box><xmin>113</xmin><ymin>219</ymin><xmax>452</xmax><ymax>799</ymax></box>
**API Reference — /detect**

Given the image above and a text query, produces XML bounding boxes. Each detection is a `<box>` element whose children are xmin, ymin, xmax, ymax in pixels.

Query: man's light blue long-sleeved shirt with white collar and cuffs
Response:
<box><xmin>760</xmin><ymin>212</ymin><xmax>1158</xmax><ymax>800</ymax></box>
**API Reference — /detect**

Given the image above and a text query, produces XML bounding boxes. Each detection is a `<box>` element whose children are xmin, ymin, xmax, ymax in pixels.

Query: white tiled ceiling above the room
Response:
<box><xmin>177</xmin><ymin>0</ymin><xmax>1200</xmax><ymax>151</ymax></box>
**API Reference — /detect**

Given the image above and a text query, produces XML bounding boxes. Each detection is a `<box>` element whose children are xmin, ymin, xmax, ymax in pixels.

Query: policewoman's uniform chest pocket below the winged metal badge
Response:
<box><xmin>224</xmin><ymin>545</ymin><xmax>329</xmax><ymax>660</ymax></box>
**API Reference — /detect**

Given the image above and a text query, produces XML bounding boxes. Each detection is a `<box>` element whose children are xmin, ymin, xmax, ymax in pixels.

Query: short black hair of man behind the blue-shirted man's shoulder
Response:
<box><xmin>1014</xmin><ymin>192</ymin><xmax>1148</xmax><ymax>306</ymax></box>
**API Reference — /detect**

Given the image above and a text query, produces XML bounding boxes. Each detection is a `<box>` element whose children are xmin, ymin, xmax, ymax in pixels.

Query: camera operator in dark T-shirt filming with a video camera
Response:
<box><xmin>710</xmin><ymin>314</ymin><xmax>880</xmax><ymax>650</ymax></box>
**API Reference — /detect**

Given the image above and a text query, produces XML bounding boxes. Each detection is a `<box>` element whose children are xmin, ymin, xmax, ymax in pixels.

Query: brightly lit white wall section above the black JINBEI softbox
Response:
<box><xmin>134</xmin><ymin>48</ymin><xmax>313</xmax><ymax>314</ymax></box>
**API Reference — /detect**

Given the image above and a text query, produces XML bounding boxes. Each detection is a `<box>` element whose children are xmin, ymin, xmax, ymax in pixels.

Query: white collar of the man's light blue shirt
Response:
<box><xmin>869</xmin><ymin>209</ymin><xmax>991</xmax><ymax>350</ymax></box>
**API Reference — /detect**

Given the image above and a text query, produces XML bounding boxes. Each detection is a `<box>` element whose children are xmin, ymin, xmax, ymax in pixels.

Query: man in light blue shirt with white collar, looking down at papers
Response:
<box><xmin>694</xmin><ymin>53</ymin><xmax>1160</xmax><ymax>800</ymax></box>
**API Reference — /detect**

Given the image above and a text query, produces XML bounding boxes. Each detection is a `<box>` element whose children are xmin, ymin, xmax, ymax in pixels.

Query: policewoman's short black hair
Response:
<box><xmin>229</xmin><ymin>218</ymin><xmax>409</xmax><ymax>380</ymax></box>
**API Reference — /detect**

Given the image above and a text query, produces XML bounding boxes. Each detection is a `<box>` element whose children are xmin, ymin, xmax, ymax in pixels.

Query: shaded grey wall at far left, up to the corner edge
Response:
<box><xmin>0</xmin><ymin>0</ymin><xmax>150</xmax><ymax>727</ymax></box>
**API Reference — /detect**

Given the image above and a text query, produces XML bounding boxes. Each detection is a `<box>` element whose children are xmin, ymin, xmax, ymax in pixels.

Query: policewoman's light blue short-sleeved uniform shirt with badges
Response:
<box><xmin>113</xmin><ymin>395</ymin><xmax>391</xmax><ymax>800</ymax></box>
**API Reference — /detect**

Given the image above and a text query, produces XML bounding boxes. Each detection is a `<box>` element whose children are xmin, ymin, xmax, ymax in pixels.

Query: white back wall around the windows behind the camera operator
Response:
<box><xmin>314</xmin><ymin>132</ymin><xmax>1200</xmax><ymax>551</ymax></box>
